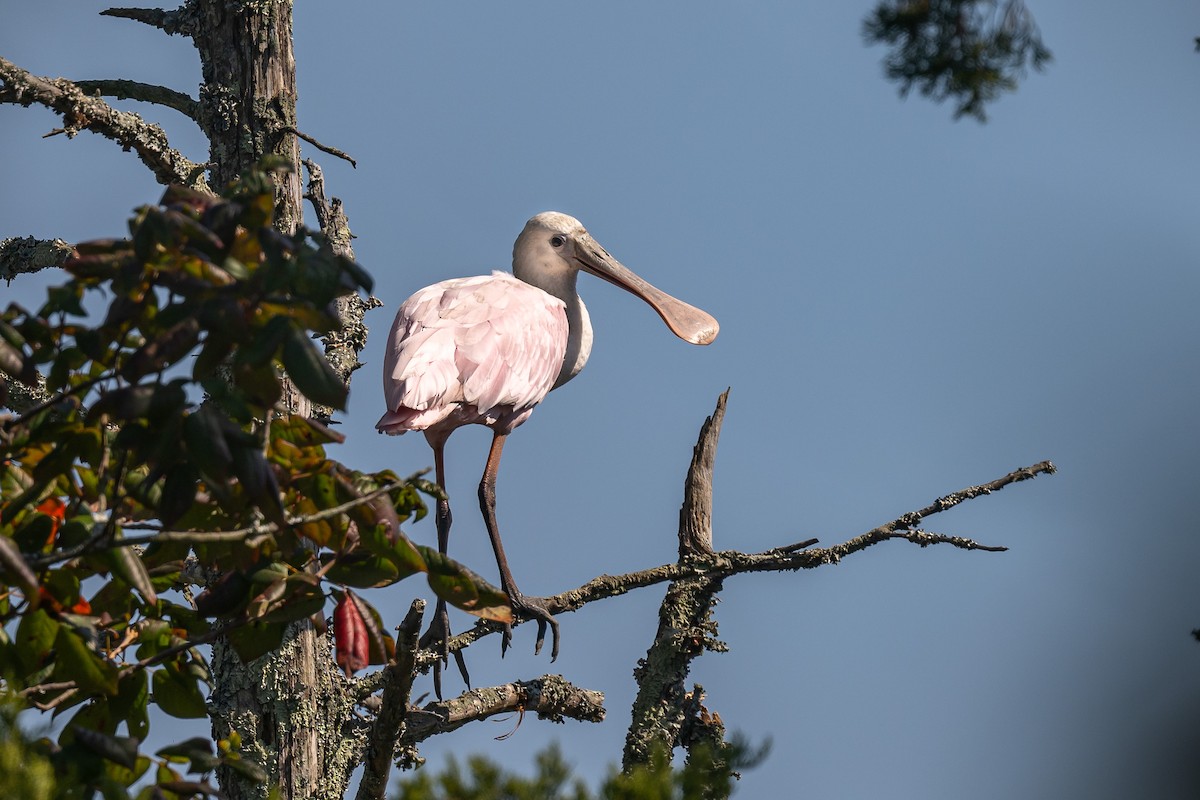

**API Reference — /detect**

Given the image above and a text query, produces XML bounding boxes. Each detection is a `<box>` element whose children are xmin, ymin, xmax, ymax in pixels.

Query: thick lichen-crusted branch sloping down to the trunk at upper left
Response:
<box><xmin>0</xmin><ymin>58</ymin><xmax>209</xmax><ymax>192</ymax></box>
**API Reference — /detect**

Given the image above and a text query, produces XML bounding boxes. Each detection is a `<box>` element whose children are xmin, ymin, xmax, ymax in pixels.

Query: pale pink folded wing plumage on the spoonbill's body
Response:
<box><xmin>376</xmin><ymin>272</ymin><xmax>568</xmax><ymax>434</ymax></box>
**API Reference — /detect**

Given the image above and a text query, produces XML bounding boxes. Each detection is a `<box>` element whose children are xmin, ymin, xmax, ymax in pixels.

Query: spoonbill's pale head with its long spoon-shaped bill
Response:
<box><xmin>512</xmin><ymin>211</ymin><xmax>720</xmax><ymax>344</ymax></box>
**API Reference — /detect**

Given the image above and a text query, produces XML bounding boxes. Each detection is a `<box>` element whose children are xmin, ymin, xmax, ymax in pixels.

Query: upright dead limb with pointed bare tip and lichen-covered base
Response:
<box><xmin>622</xmin><ymin>390</ymin><xmax>730</xmax><ymax>771</ymax></box>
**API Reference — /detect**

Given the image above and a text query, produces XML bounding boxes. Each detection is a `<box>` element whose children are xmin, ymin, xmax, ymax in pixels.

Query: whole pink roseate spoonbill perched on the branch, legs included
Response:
<box><xmin>376</xmin><ymin>211</ymin><xmax>718</xmax><ymax>696</ymax></box>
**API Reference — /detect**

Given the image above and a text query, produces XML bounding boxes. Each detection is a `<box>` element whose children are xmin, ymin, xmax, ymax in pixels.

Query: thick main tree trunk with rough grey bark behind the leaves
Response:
<box><xmin>180</xmin><ymin>0</ymin><xmax>350</xmax><ymax>800</ymax></box>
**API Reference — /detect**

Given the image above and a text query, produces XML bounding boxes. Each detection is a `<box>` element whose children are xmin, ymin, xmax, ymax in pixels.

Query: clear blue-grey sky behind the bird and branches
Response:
<box><xmin>0</xmin><ymin>0</ymin><xmax>1200</xmax><ymax>798</ymax></box>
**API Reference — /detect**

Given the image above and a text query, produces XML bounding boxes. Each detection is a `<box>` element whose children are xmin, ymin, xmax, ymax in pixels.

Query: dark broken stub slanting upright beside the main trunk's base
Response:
<box><xmin>358</xmin><ymin>600</ymin><xmax>425</xmax><ymax>800</ymax></box>
